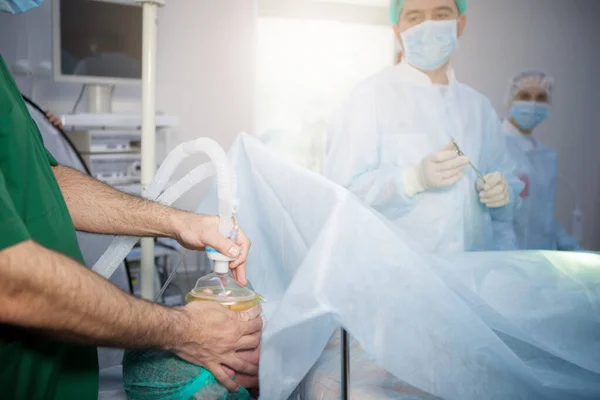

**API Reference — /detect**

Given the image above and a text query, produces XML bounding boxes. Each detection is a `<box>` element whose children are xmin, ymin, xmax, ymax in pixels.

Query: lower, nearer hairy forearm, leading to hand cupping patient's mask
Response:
<box><xmin>0</xmin><ymin>241</ymin><xmax>187</xmax><ymax>349</ymax></box>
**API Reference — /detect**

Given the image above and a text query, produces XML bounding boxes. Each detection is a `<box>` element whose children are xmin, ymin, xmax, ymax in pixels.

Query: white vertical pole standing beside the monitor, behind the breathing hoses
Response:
<box><xmin>137</xmin><ymin>0</ymin><xmax>164</xmax><ymax>300</ymax></box>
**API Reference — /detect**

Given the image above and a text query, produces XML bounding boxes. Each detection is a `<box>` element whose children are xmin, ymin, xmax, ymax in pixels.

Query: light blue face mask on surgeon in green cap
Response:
<box><xmin>400</xmin><ymin>20</ymin><xmax>458</xmax><ymax>71</ymax></box>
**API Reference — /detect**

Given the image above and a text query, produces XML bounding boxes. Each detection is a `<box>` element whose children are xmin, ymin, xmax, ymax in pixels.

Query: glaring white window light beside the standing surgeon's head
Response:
<box><xmin>256</xmin><ymin>17</ymin><xmax>394</xmax><ymax>171</ymax></box>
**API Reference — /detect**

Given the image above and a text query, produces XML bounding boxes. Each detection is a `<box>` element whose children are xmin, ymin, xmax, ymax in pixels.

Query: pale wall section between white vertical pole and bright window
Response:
<box><xmin>157</xmin><ymin>0</ymin><xmax>256</xmax><ymax>210</ymax></box>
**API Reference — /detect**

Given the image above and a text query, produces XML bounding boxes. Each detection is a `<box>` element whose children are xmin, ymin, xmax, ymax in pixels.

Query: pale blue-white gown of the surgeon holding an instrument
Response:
<box><xmin>325</xmin><ymin>63</ymin><xmax>523</xmax><ymax>252</ymax></box>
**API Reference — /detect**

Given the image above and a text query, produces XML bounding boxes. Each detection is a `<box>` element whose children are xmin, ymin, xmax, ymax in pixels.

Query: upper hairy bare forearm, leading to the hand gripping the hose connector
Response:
<box><xmin>53</xmin><ymin>166</ymin><xmax>183</xmax><ymax>237</ymax></box>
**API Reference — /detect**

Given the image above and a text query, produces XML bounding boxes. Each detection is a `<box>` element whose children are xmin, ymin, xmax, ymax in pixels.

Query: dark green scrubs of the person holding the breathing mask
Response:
<box><xmin>0</xmin><ymin>56</ymin><xmax>98</xmax><ymax>400</ymax></box>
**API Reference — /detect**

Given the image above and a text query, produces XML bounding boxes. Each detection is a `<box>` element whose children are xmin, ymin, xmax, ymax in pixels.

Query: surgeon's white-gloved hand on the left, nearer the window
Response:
<box><xmin>402</xmin><ymin>143</ymin><xmax>469</xmax><ymax>197</ymax></box>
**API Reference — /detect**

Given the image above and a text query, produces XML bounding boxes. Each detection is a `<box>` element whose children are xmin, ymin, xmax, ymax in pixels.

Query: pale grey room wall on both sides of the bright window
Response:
<box><xmin>0</xmin><ymin>0</ymin><xmax>600</xmax><ymax>249</ymax></box>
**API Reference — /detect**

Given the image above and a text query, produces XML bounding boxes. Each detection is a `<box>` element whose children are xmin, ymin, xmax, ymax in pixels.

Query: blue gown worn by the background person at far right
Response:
<box><xmin>494</xmin><ymin>121</ymin><xmax>579</xmax><ymax>250</ymax></box>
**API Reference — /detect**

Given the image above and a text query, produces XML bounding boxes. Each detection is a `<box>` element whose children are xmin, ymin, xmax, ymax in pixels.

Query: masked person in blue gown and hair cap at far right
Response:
<box><xmin>494</xmin><ymin>70</ymin><xmax>580</xmax><ymax>250</ymax></box>
